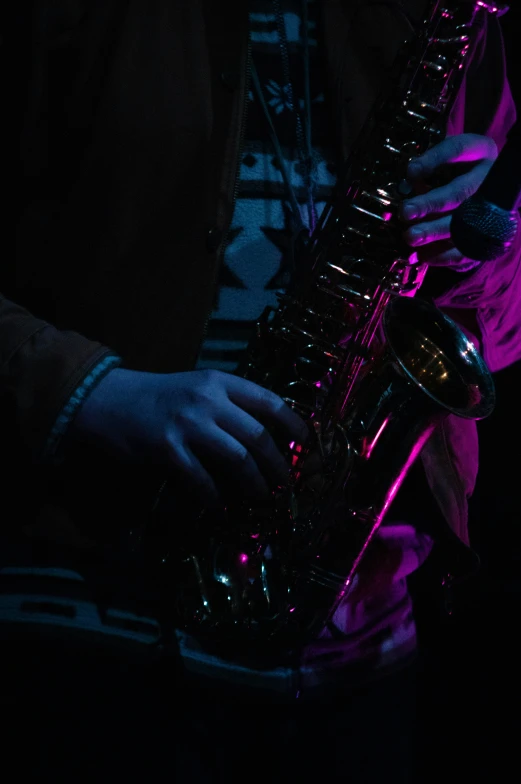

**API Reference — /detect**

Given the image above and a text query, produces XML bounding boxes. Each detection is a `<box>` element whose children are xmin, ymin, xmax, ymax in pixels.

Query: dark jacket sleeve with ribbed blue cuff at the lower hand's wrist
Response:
<box><xmin>0</xmin><ymin>294</ymin><xmax>119</xmax><ymax>462</ymax></box>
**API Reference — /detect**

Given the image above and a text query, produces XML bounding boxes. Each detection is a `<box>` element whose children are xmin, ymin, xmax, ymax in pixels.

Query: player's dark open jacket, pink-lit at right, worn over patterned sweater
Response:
<box><xmin>0</xmin><ymin>0</ymin><xmax>521</xmax><ymax>560</ymax></box>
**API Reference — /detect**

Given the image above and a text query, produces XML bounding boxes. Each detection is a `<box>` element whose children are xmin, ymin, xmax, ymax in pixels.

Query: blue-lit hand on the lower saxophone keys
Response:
<box><xmin>72</xmin><ymin>368</ymin><xmax>308</xmax><ymax>502</ymax></box>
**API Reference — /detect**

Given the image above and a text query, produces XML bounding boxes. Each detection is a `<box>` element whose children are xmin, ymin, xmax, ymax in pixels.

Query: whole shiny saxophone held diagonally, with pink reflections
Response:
<box><xmin>137</xmin><ymin>0</ymin><xmax>498</xmax><ymax>646</ymax></box>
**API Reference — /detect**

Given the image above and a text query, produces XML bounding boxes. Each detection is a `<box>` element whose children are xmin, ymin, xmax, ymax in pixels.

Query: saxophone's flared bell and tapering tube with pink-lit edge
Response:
<box><xmin>280</xmin><ymin>297</ymin><xmax>495</xmax><ymax>638</ymax></box>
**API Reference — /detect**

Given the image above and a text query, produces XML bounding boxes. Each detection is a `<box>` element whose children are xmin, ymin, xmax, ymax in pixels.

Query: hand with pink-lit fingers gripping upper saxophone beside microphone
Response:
<box><xmin>400</xmin><ymin>133</ymin><xmax>498</xmax><ymax>272</ymax></box>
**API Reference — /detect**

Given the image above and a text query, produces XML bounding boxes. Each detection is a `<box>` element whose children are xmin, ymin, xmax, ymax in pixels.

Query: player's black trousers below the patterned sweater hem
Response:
<box><xmin>0</xmin><ymin>645</ymin><xmax>421</xmax><ymax>784</ymax></box>
